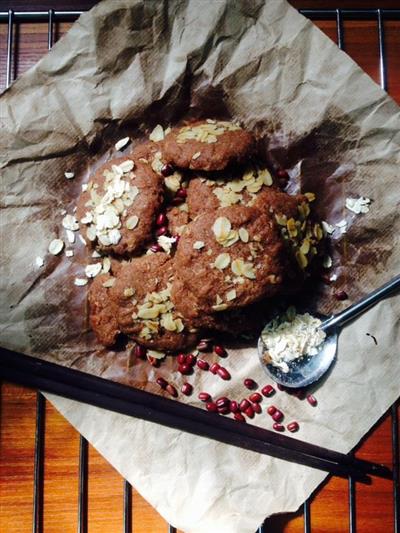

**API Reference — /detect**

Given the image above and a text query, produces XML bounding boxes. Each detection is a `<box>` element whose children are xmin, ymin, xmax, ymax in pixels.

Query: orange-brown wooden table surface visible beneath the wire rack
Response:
<box><xmin>0</xmin><ymin>0</ymin><xmax>400</xmax><ymax>533</ymax></box>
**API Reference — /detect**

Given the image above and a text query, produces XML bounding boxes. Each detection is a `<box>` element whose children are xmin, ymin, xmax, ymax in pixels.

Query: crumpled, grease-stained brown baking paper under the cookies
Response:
<box><xmin>0</xmin><ymin>0</ymin><xmax>400</xmax><ymax>533</ymax></box>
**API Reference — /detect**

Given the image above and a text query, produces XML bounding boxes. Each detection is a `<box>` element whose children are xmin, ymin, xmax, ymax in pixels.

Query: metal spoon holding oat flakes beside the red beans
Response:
<box><xmin>258</xmin><ymin>276</ymin><xmax>400</xmax><ymax>388</ymax></box>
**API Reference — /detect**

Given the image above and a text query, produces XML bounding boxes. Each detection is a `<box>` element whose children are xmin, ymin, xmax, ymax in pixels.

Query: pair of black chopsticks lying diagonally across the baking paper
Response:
<box><xmin>0</xmin><ymin>350</ymin><xmax>392</xmax><ymax>483</ymax></box>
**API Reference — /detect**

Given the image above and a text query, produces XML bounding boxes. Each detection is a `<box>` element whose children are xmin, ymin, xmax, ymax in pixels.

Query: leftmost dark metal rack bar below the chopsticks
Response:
<box><xmin>32</xmin><ymin>392</ymin><xmax>46</xmax><ymax>533</ymax></box>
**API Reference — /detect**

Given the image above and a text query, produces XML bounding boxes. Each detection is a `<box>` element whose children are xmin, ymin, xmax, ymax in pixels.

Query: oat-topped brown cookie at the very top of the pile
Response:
<box><xmin>163</xmin><ymin>120</ymin><xmax>255</xmax><ymax>171</ymax></box>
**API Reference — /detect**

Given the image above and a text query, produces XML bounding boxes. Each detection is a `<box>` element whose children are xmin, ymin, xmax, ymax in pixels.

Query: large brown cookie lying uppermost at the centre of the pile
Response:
<box><xmin>172</xmin><ymin>206</ymin><xmax>286</xmax><ymax>318</ymax></box>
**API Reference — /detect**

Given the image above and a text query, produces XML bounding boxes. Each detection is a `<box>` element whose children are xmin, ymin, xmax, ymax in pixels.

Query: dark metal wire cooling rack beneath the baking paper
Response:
<box><xmin>0</xmin><ymin>5</ymin><xmax>400</xmax><ymax>533</ymax></box>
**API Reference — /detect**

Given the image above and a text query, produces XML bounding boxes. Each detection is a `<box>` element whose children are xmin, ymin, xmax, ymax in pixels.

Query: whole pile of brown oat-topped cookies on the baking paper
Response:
<box><xmin>82</xmin><ymin>119</ymin><xmax>323</xmax><ymax>353</ymax></box>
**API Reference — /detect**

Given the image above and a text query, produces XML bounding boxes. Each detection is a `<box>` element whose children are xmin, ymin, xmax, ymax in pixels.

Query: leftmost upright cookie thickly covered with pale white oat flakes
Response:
<box><xmin>76</xmin><ymin>157</ymin><xmax>163</xmax><ymax>255</ymax></box>
